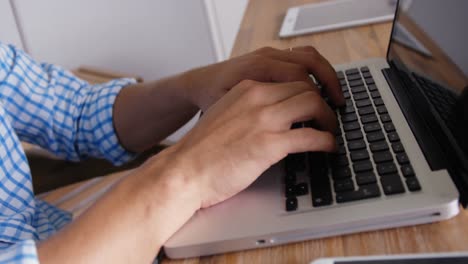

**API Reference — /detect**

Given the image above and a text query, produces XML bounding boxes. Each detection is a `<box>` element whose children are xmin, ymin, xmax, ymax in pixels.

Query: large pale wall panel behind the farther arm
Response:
<box><xmin>14</xmin><ymin>0</ymin><xmax>216</xmax><ymax>80</ymax></box>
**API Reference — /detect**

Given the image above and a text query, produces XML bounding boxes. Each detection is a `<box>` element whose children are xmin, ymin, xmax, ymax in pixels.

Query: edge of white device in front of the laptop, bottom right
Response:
<box><xmin>311</xmin><ymin>252</ymin><xmax>468</xmax><ymax>264</ymax></box>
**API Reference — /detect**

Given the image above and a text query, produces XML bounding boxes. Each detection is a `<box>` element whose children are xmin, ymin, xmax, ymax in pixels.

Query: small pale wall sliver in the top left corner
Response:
<box><xmin>0</xmin><ymin>0</ymin><xmax>23</xmax><ymax>48</ymax></box>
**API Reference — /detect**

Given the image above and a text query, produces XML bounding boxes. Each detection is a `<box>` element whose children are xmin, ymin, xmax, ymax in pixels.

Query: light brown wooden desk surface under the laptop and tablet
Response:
<box><xmin>43</xmin><ymin>0</ymin><xmax>468</xmax><ymax>263</ymax></box>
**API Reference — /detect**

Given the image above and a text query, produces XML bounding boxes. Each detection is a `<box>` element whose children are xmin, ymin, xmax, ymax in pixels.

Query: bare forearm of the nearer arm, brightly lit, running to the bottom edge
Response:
<box><xmin>38</xmin><ymin>150</ymin><xmax>200</xmax><ymax>263</ymax></box>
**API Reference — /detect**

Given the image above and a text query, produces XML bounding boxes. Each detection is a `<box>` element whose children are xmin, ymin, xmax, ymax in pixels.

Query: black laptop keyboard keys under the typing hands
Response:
<box><xmin>284</xmin><ymin>67</ymin><xmax>421</xmax><ymax>211</ymax></box>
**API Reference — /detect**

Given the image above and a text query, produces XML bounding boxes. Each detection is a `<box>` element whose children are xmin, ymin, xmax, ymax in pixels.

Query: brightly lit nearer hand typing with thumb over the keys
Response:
<box><xmin>156</xmin><ymin>81</ymin><xmax>337</xmax><ymax>207</ymax></box>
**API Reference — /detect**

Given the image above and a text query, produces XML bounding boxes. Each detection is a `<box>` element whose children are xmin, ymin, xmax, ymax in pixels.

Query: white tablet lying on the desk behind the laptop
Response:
<box><xmin>279</xmin><ymin>0</ymin><xmax>397</xmax><ymax>38</ymax></box>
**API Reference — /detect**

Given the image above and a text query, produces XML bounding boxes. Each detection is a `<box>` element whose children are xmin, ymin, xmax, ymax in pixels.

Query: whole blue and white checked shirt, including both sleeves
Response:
<box><xmin>0</xmin><ymin>43</ymin><xmax>134</xmax><ymax>263</ymax></box>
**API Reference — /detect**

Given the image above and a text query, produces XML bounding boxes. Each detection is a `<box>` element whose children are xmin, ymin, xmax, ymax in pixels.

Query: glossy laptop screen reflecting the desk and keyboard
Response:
<box><xmin>387</xmin><ymin>0</ymin><xmax>468</xmax><ymax>198</ymax></box>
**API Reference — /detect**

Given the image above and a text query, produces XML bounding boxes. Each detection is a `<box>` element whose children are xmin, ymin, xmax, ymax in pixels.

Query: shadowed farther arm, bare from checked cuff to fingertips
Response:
<box><xmin>114</xmin><ymin>47</ymin><xmax>344</xmax><ymax>152</ymax></box>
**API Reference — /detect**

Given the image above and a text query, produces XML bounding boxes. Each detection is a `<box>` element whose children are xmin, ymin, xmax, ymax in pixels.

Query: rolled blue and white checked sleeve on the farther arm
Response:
<box><xmin>0</xmin><ymin>44</ymin><xmax>135</xmax><ymax>165</ymax></box>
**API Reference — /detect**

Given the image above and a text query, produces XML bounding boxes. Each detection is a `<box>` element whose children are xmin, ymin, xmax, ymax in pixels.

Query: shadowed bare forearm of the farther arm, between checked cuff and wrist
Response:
<box><xmin>114</xmin><ymin>74</ymin><xmax>198</xmax><ymax>152</ymax></box>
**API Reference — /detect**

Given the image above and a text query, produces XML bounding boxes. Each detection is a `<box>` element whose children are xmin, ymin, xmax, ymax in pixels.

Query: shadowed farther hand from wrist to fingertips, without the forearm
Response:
<box><xmin>186</xmin><ymin>46</ymin><xmax>344</xmax><ymax>111</ymax></box>
